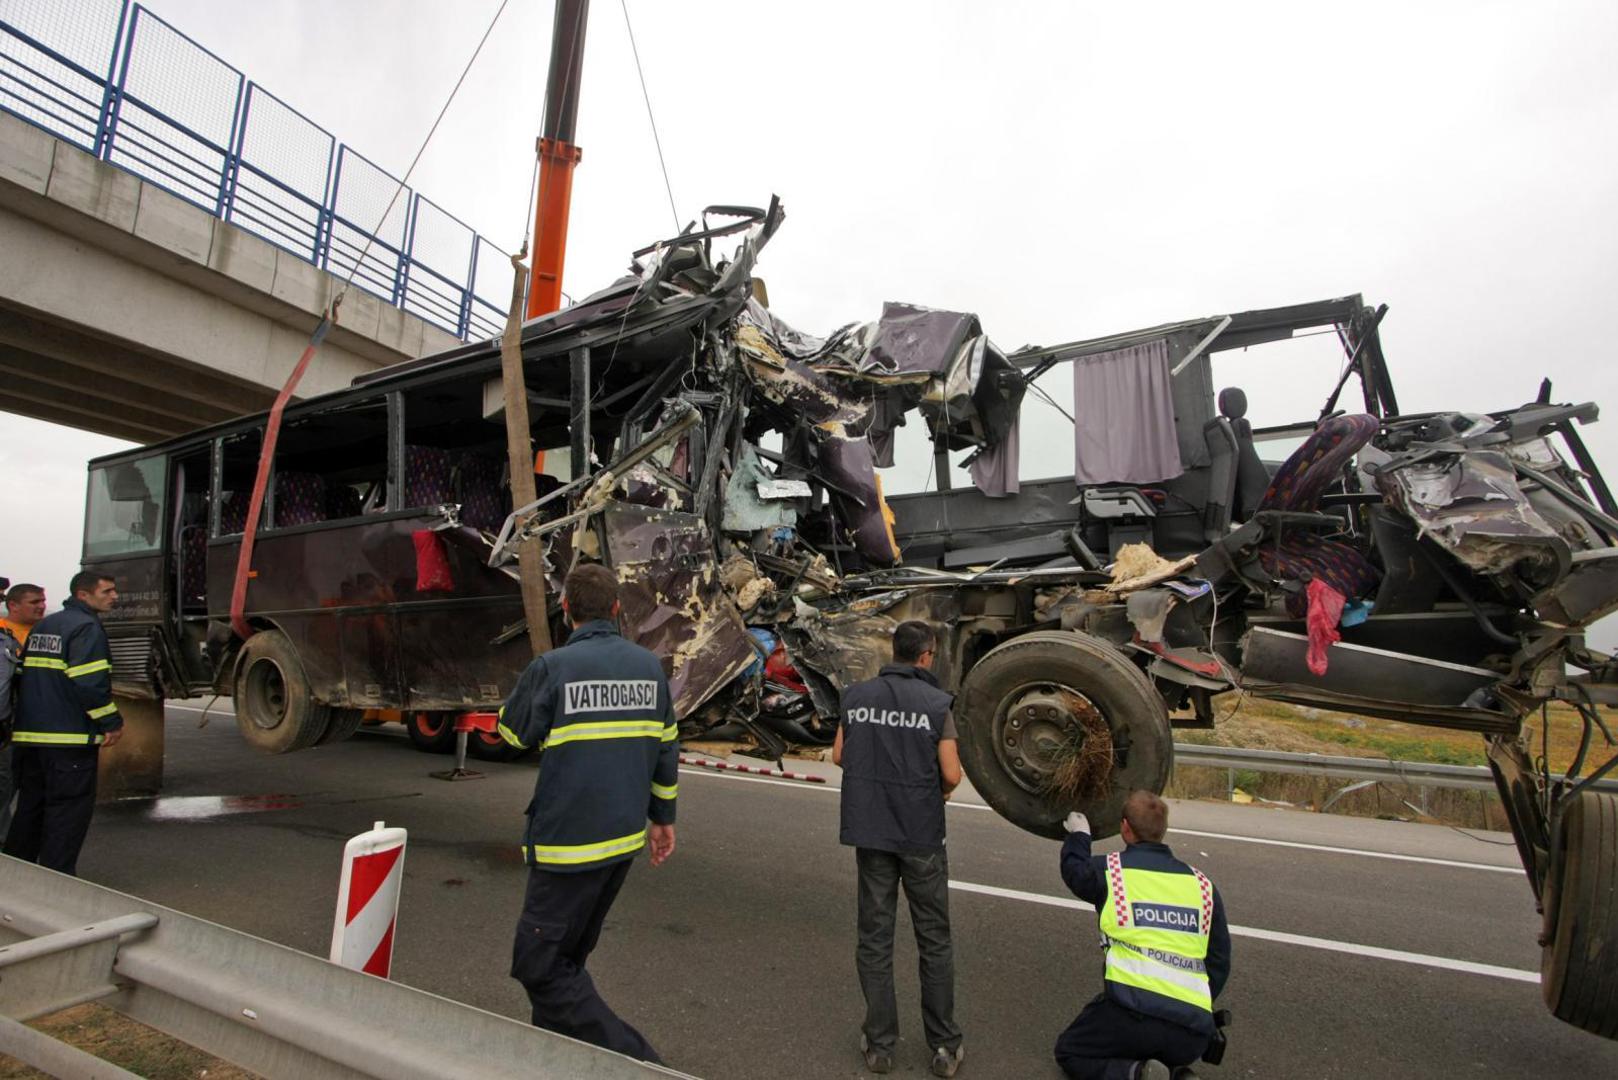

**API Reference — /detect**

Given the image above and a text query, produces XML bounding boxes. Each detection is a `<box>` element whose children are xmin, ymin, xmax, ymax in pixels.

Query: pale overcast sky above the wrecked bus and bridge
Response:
<box><xmin>0</xmin><ymin>0</ymin><xmax>1618</xmax><ymax>621</ymax></box>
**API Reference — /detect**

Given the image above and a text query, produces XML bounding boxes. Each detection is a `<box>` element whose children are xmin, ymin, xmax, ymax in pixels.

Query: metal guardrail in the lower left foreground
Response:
<box><xmin>0</xmin><ymin>857</ymin><xmax>684</xmax><ymax>1080</ymax></box>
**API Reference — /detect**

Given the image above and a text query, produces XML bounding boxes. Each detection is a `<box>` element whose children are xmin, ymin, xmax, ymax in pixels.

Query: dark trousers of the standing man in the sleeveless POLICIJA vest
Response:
<box><xmin>854</xmin><ymin>847</ymin><xmax>961</xmax><ymax>1051</ymax></box>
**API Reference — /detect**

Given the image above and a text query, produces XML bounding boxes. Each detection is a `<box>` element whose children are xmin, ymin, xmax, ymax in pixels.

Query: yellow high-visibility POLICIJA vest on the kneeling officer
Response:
<box><xmin>1099</xmin><ymin>852</ymin><xmax>1214</xmax><ymax>1028</ymax></box>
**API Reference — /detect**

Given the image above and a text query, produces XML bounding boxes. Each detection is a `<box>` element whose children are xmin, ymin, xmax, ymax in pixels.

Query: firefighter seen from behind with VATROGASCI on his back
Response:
<box><xmin>497</xmin><ymin>565</ymin><xmax>680</xmax><ymax>1062</ymax></box>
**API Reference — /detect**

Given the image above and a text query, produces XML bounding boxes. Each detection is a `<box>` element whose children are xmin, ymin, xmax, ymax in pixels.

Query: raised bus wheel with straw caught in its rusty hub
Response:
<box><xmin>955</xmin><ymin>630</ymin><xmax>1175</xmax><ymax>839</ymax></box>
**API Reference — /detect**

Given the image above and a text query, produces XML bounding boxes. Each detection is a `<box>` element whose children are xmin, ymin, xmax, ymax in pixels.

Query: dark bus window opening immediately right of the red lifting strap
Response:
<box><xmin>273</xmin><ymin>398</ymin><xmax>388</xmax><ymax>528</ymax></box>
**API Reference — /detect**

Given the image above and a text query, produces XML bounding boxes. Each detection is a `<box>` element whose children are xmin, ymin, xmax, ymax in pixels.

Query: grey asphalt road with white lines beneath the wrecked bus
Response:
<box><xmin>47</xmin><ymin>704</ymin><xmax>1618</xmax><ymax>1078</ymax></box>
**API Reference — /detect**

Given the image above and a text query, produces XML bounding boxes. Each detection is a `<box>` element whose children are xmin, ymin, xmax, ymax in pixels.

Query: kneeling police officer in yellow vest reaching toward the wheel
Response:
<box><xmin>1057</xmin><ymin>792</ymin><xmax>1230</xmax><ymax>1080</ymax></box>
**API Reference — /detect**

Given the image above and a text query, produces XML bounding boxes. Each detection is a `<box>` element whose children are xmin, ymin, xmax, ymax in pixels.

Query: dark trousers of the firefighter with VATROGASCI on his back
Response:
<box><xmin>511</xmin><ymin>858</ymin><xmax>662</xmax><ymax>1062</ymax></box>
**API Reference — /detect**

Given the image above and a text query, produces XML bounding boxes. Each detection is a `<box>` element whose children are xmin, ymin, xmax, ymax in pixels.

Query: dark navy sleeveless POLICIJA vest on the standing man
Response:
<box><xmin>840</xmin><ymin>664</ymin><xmax>951</xmax><ymax>855</ymax></box>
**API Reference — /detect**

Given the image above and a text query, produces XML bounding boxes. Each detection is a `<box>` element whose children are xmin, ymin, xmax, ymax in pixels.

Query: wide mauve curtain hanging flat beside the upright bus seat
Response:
<box><xmin>1073</xmin><ymin>340</ymin><xmax>1184</xmax><ymax>487</ymax></box>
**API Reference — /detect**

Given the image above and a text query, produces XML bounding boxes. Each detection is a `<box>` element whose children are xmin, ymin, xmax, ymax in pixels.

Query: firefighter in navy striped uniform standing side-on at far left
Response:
<box><xmin>5</xmin><ymin>570</ymin><xmax>123</xmax><ymax>874</ymax></box>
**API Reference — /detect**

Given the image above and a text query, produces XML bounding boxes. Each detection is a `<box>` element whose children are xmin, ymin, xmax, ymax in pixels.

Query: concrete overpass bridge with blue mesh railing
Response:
<box><xmin>0</xmin><ymin>0</ymin><xmax>511</xmax><ymax>442</ymax></box>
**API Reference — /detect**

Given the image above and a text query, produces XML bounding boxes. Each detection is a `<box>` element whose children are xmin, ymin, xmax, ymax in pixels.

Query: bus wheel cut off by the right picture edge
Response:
<box><xmin>1540</xmin><ymin>792</ymin><xmax>1618</xmax><ymax>1038</ymax></box>
